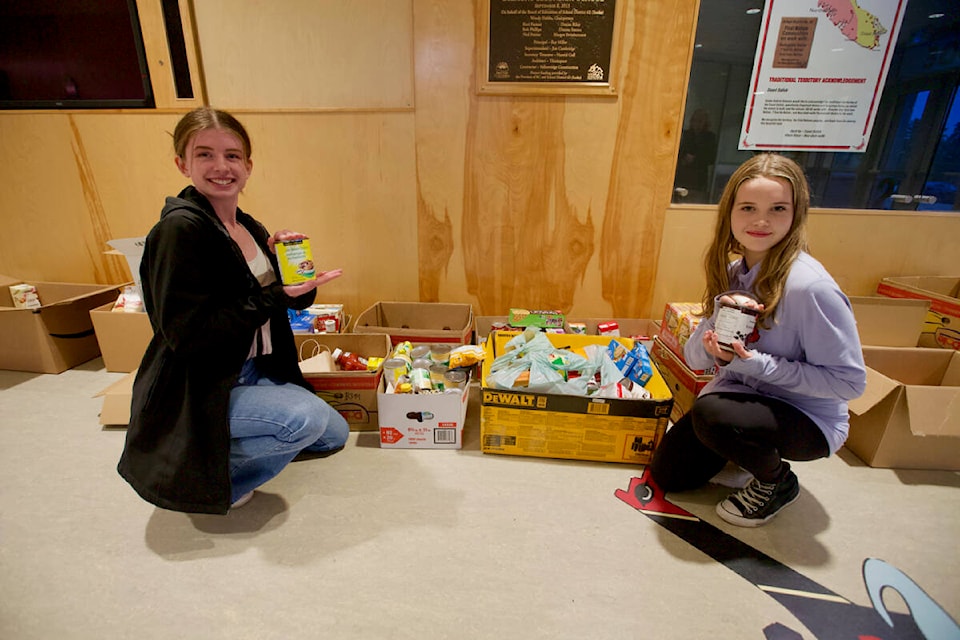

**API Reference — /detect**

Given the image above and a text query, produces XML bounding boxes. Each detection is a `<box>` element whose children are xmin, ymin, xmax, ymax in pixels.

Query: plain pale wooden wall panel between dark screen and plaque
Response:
<box><xmin>193</xmin><ymin>0</ymin><xmax>413</xmax><ymax>109</ymax></box>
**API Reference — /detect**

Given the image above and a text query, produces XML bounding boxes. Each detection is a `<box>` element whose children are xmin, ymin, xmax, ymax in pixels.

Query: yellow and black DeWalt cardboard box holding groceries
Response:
<box><xmin>480</xmin><ymin>332</ymin><xmax>673</xmax><ymax>464</ymax></box>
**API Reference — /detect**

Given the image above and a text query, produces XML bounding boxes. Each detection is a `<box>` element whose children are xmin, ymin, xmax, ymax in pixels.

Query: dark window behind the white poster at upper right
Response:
<box><xmin>673</xmin><ymin>0</ymin><xmax>960</xmax><ymax>211</ymax></box>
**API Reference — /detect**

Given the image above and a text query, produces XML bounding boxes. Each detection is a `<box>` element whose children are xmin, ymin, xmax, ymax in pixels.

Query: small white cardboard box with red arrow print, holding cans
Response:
<box><xmin>377</xmin><ymin>376</ymin><xmax>470</xmax><ymax>449</ymax></box>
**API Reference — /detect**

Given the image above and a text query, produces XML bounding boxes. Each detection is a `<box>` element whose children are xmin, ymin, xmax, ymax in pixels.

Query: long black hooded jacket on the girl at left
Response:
<box><xmin>117</xmin><ymin>186</ymin><xmax>316</xmax><ymax>513</ymax></box>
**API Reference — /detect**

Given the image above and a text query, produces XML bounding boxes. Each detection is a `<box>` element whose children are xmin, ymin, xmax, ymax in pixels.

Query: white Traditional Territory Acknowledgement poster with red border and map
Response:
<box><xmin>739</xmin><ymin>0</ymin><xmax>907</xmax><ymax>152</ymax></box>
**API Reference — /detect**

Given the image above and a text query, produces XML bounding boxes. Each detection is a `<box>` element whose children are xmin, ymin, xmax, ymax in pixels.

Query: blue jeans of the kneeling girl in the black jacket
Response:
<box><xmin>229</xmin><ymin>360</ymin><xmax>350</xmax><ymax>501</ymax></box>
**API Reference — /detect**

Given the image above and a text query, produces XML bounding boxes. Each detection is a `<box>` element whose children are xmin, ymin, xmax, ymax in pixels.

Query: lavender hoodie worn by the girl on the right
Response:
<box><xmin>684</xmin><ymin>253</ymin><xmax>866</xmax><ymax>454</ymax></box>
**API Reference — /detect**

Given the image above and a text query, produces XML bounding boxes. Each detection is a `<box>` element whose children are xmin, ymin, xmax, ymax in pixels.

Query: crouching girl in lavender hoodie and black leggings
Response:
<box><xmin>650</xmin><ymin>153</ymin><xmax>866</xmax><ymax>527</ymax></box>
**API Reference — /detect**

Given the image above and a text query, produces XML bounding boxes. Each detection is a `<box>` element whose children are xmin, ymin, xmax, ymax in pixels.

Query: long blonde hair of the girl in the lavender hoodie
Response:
<box><xmin>703</xmin><ymin>153</ymin><xmax>810</xmax><ymax>328</ymax></box>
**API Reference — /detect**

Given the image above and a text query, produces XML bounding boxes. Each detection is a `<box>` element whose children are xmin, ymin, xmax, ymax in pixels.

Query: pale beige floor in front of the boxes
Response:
<box><xmin>0</xmin><ymin>359</ymin><xmax>960</xmax><ymax>640</ymax></box>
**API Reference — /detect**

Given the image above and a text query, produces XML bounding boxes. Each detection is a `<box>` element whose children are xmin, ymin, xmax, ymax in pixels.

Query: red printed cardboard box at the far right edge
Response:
<box><xmin>877</xmin><ymin>276</ymin><xmax>960</xmax><ymax>350</ymax></box>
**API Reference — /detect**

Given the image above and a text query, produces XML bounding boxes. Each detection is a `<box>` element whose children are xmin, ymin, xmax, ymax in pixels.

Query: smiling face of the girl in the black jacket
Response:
<box><xmin>176</xmin><ymin>129</ymin><xmax>253</xmax><ymax>208</ymax></box>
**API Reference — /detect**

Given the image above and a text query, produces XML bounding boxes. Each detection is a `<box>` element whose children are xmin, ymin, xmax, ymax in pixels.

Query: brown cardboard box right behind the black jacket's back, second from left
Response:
<box><xmin>90</xmin><ymin>302</ymin><xmax>153</xmax><ymax>373</ymax></box>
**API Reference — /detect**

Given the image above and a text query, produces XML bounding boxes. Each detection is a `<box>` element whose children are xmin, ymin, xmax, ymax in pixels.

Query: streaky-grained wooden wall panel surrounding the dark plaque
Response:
<box><xmin>414</xmin><ymin>0</ymin><xmax>696</xmax><ymax>316</ymax></box>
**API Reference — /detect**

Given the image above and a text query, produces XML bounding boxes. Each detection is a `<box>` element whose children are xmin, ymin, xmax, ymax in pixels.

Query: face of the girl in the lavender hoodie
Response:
<box><xmin>730</xmin><ymin>177</ymin><xmax>793</xmax><ymax>268</ymax></box>
